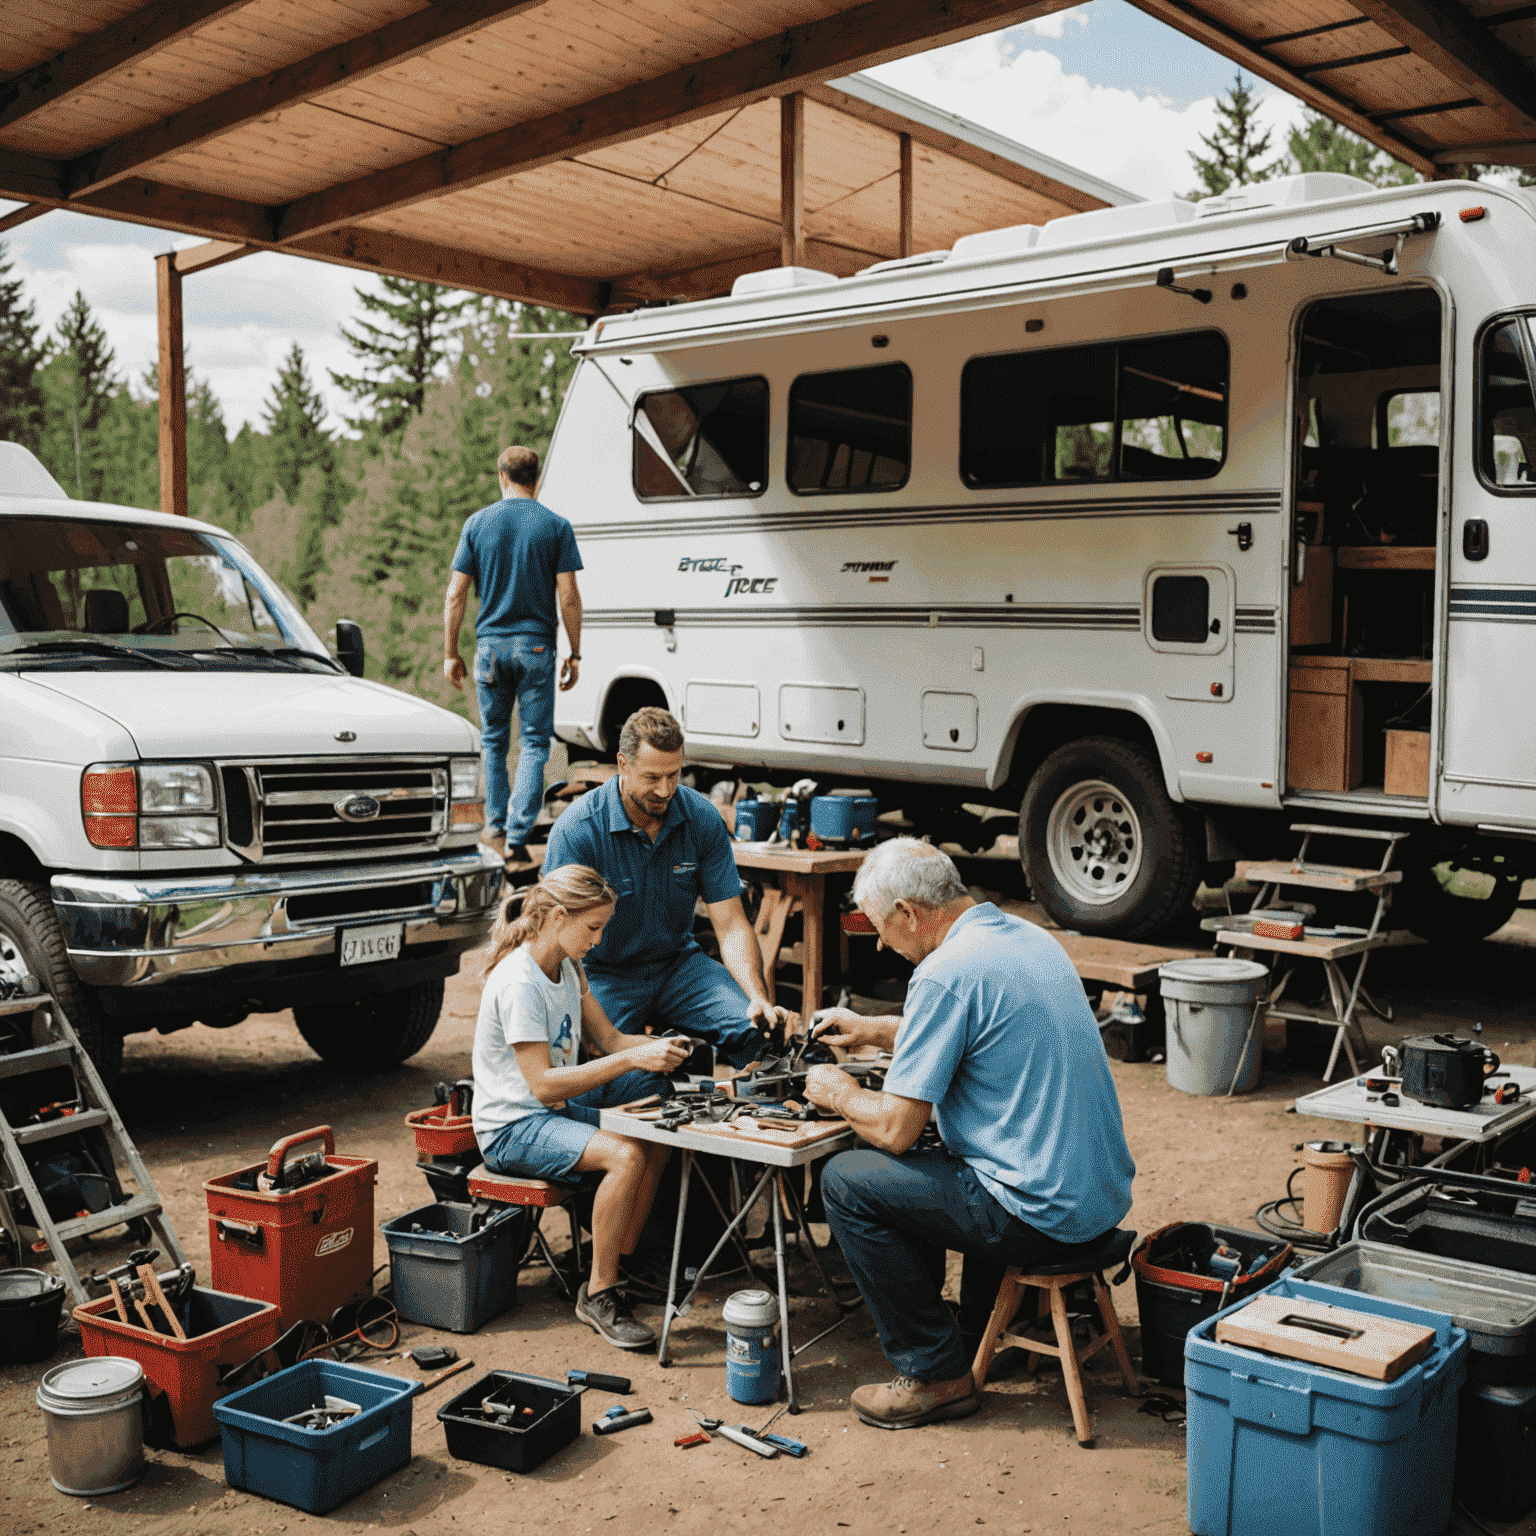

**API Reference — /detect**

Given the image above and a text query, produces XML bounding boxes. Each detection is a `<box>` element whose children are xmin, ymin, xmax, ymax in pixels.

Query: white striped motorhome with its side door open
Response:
<box><xmin>541</xmin><ymin>175</ymin><xmax>1536</xmax><ymax>937</ymax></box>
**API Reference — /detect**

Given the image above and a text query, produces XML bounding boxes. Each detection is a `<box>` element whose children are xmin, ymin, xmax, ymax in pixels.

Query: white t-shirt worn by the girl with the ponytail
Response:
<box><xmin>473</xmin><ymin>945</ymin><xmax>585</xmax><ymax>1150</ymax></box>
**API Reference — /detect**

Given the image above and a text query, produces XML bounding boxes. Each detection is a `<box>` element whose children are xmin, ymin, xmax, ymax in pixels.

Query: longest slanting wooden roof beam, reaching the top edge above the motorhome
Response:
<box><xmin>276</xmin><ymin>0</ymin><xmax>1077</xmax><ymax>241</ymax></box>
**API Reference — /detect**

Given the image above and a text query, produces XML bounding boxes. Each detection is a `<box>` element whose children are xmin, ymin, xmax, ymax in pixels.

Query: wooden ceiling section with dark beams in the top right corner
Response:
<box><xmin>1130</xmin><ymin>0</ymin><xmax>1536</xmax><ymax>177</ymax></box>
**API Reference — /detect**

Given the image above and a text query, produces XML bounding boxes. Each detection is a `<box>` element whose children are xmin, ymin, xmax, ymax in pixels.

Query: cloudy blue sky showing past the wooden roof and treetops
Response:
<box><xmin>0</xmin><ymin>0</ymin><xmax>1299</xmax><ymax>430</ymax></box>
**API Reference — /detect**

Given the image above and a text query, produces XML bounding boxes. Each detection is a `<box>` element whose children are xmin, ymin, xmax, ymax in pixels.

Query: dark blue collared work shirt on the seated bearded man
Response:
<box><xmin>544</xmin><ymin>774</ymin><xmax>742</xmax><ymax>971</ymax></box>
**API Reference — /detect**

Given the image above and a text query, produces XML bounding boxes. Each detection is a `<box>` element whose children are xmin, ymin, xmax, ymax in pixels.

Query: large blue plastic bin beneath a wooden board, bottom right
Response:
<box><xmin>1184</xmin><ymin>1279</ymin><xmax>1467</xmax><ymax>1536</ymax></box>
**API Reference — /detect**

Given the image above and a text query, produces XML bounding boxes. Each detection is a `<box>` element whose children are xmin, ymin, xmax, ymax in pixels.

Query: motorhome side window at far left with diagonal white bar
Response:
<box><xmin>634</xmin><ymin>378</ymin><xmax>768</xmax><ymax>501</ymax></box>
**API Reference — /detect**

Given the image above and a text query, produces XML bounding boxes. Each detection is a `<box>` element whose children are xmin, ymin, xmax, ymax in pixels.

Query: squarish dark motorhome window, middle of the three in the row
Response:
<box><xmin>786</xmin><ymin>362</ymin><xmax>912</xmax><ymax>495</ymax></box>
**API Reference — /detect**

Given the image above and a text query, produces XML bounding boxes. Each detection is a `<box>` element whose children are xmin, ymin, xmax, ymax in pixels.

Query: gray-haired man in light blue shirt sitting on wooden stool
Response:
<box><xmin>805</xmin><ymin>837</ymin><xmax>1135</xmax><ymax>1428</ymax></box>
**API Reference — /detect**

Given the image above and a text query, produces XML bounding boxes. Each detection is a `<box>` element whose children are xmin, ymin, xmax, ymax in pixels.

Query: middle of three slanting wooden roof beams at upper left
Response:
<box><xmin>68</xmin><ymin>0</ymin><xmax>559</xmax><ymax>197</ymax></box>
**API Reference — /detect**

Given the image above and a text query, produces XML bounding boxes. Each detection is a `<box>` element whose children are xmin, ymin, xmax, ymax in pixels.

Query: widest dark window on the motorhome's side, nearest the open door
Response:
<box><xmin>960</xmin><ymin>330</ymin><xmax>1229</xmax><ymax>487</ymax></box>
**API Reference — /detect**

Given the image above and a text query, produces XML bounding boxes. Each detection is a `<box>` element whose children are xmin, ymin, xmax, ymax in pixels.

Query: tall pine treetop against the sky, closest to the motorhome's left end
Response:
<box><xmin>330</xmin><ymin>276</ymin><xmax>470</xmax><ymax>436</ymax></box>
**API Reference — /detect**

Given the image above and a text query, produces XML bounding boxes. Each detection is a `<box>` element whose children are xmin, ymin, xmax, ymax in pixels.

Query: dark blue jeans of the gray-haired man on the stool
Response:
<box><xmin>822</xmin><ymin>1147</ymin><xmax>1103</xmax><ymax>1381</ymax></box>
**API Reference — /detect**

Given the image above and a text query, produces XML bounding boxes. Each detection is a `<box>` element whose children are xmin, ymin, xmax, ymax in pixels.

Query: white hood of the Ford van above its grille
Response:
<box><xmin>28</xmin><ymin>670</ymin><xmax>479</xmax><ymax>757</ymax></box>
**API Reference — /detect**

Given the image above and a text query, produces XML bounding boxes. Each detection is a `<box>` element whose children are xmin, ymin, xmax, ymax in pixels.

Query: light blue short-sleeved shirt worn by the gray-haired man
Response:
<box><xmin>884</xmin><ymin>903</ymin><xmax>1137</xmax><ymax>1243</ymax></box>
